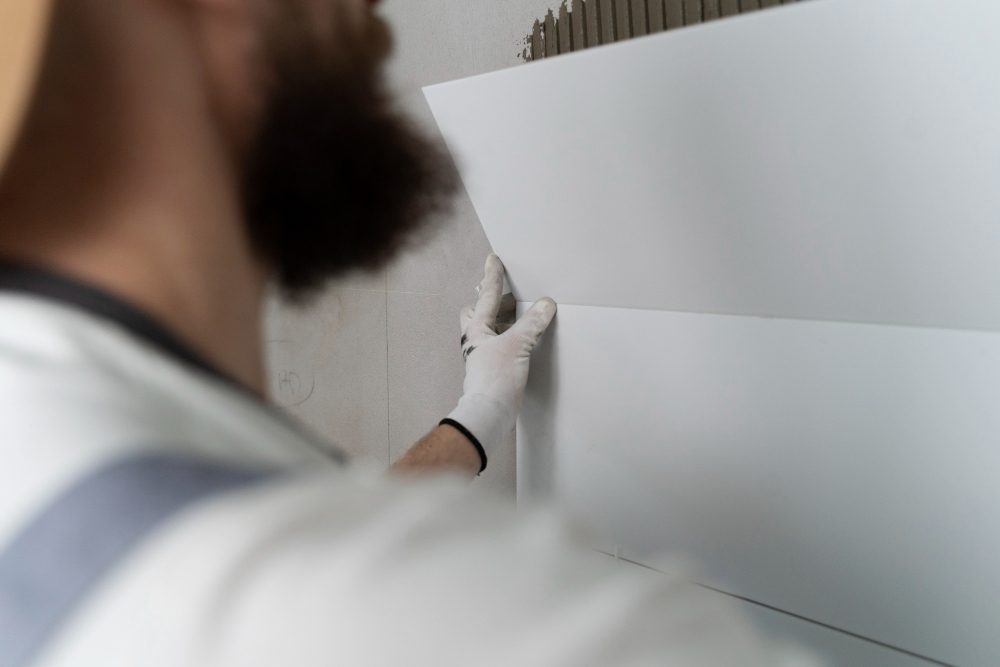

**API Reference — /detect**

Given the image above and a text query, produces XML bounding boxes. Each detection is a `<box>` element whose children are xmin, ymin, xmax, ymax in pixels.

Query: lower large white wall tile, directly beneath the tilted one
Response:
<box><xmin>518</xmin><ymin>305</ymin><xmax>1000</xmax><ymax>665</ymax></box>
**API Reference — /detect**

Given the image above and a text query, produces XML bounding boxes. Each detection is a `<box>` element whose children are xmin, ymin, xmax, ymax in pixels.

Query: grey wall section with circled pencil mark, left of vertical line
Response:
<box><xmin>266</xmin><ymin>283</ymin><xmax>389</xmax><ymax>467</ymax></box>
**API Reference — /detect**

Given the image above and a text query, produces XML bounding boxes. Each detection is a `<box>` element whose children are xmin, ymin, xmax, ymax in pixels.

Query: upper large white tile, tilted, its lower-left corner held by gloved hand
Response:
<box><xmin>425</xmin><ymin>0</ymin><xmax>1000</xmax><ymax>330</ymax></box>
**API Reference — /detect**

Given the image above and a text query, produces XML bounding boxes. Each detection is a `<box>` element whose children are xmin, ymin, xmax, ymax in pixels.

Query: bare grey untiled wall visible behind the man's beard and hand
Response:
<box><xmin>266</xmin><ymin>0</ymin><xmax>554</xmax><ymax>498</ymax></box>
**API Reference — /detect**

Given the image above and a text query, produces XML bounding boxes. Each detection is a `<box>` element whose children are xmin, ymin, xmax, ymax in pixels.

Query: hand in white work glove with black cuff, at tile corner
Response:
<box><xmin>441</xmin><ymin>254</ymin><xmax>556</xmax><ymax>468</ymax></box>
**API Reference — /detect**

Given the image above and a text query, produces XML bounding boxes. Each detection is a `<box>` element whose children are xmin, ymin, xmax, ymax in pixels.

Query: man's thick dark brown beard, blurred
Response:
<box><xmin>243</xmin><ymin>18</ymin><xmax>456</xmax><ymax>298</ymax></box>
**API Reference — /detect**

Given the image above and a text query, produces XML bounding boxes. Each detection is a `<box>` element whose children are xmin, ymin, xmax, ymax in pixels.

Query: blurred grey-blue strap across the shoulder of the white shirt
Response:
<box><xmin>0</xmin><ymin>454</ymin><xmax>274</xmax><ymax>667</ymax></box>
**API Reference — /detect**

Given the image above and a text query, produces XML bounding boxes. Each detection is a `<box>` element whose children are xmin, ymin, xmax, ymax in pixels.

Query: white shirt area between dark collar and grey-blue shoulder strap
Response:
<box><xmin>0</xmin><ymin>294</ymin><xmax>338</xmax><ymax>545</ymax></box>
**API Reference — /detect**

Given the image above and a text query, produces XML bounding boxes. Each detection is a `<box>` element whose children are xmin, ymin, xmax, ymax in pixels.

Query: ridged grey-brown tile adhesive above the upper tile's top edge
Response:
<box><xmin>518</xmin><ymin>0</ymin><xmax>800</xmax><ymax>61</ymax></box>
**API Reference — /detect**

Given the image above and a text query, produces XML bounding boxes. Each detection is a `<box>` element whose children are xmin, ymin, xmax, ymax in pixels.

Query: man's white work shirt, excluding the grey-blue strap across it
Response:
<box><xmin>0</xmin><ymin>268</ymin><xmax>812</xmax><ymax>667</ymax></box>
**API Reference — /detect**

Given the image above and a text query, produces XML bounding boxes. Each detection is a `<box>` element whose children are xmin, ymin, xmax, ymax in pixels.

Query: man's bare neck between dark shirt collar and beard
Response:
<box><xmin>0</xmin><ymin>3</ymin><xmax>268</xmax><ymax>394</ymax></box>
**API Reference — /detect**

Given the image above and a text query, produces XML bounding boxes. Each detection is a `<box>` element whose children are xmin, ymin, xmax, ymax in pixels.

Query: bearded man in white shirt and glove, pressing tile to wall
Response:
<box><xmin>0</xmin><ymin>0</ymin><xmax>804</xmax><ymax>667</ymax></box>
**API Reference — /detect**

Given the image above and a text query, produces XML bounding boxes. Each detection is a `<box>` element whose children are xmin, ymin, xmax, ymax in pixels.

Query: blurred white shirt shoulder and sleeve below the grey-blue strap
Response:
<box><xmin>33</xmin><ymin>471</ymin><xmax>808</xmax><ymax>667</ymax></box>
